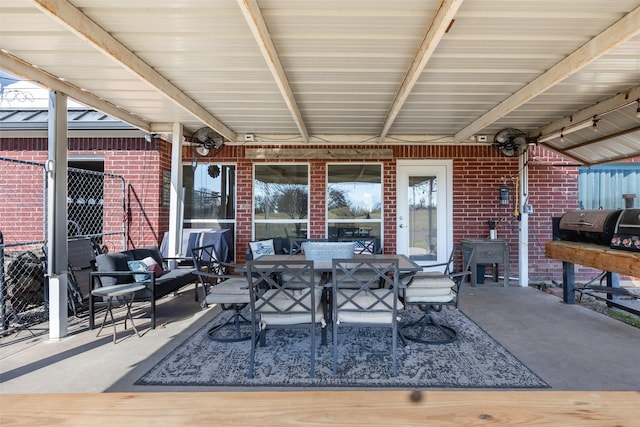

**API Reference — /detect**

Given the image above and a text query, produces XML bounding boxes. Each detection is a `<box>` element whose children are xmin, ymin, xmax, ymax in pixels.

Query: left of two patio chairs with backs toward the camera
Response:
<box><xmin>247</xmin><ymin>259</ymin><xmax>327</xmax><ymax>378</ymax></box>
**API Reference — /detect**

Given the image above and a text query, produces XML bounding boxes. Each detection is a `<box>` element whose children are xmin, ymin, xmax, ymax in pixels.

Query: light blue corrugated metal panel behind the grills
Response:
<box><xmin>578</xmin><ymin>164</ymin><xmax>640</xmax><ymax>209</ymax></box>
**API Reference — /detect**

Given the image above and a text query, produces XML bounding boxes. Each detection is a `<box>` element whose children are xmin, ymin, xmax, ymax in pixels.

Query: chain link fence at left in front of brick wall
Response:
<box><xmin>0</xmin><ymin>157</ymin><xmax>126</xmax><ymax>335</ymax></box>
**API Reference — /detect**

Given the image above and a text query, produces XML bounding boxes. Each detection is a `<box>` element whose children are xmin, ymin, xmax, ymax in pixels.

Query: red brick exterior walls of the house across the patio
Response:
<box><xmin>0</xmin><ymin>138</ymin><xmax>620</xmax><ymax>282</ymax></box>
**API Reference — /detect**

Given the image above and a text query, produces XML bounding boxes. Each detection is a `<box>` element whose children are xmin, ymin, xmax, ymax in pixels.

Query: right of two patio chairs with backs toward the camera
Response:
<box><xmin>332</xmin><ymin>258</ymin><xmax>399</xmax><ymax>377</ymax></box>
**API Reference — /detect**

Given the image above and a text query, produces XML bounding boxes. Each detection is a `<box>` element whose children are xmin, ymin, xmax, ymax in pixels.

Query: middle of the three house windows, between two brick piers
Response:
<box><xmin>253</xmin><ymin>163</ymin><xmax>309</xmax><ymax>239</ymax></box>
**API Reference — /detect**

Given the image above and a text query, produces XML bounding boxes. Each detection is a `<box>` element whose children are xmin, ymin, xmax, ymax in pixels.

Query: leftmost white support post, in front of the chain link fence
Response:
<box><xmin>46</xmin><ymin>92</ymin><xmax>68</xmax><ymax>340</ymax></box>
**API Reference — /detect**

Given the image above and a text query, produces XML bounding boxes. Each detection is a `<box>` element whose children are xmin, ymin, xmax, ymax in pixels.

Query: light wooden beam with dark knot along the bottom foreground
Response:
<box><xmin>0</xmin><ymin>390</ymin><xmax>640</xmax><ymax>427</ymax></box>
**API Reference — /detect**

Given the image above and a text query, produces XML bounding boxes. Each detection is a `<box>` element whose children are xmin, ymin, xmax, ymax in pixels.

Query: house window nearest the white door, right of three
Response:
<box><xmin>327</xmin><ymin>163</ymin><xmax>382</xmax><ymax>247</ymax></box>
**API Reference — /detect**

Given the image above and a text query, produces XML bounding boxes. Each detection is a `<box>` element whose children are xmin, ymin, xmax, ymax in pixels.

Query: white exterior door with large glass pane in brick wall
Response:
<box><xmin>397</xmin><ymin>160</ymin><xmax>453</xmax><ymax>265</ymax></box>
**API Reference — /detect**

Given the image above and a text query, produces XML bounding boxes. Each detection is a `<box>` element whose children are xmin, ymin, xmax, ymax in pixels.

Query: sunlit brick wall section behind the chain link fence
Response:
<box><xmin>0</xmin><ymin>138</ymin><xmax>171</xmax><ymax>250</ymax></box>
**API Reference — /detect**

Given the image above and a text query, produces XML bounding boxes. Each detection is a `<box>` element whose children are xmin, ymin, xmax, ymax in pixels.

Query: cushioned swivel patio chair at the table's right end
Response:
<box><xmin>400</xmin><ymin>245</ymin><xmax>475</xmax><ymax>344</ymax></box>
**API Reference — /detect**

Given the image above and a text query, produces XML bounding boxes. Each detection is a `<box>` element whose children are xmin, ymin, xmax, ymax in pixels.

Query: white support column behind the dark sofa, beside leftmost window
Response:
<box><xmin>168</xmin><ymin>123</ymin><xmax>184</xmax><ymax>266</ymax></box>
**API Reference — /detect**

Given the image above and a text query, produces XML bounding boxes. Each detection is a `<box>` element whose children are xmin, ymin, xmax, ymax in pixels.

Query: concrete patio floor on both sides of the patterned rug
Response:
<box><xmin>0</xmin><ymin>284</ymin><xmax>640</xmax><ymax>394</ymax></box>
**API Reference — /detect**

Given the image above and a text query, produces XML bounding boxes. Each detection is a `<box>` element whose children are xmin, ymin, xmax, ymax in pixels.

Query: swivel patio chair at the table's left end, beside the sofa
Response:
<box><xmin>191</xmin><ymin>245</ymin><xmax>251</xmax><ymax>342</ymax></box>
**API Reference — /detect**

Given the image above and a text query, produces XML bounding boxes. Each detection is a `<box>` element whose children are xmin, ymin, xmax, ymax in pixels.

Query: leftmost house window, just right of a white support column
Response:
<box><xmin>182</xmin><ymin>163</ymin><xmax>236</xmax><ymax>231</ymax></box>
